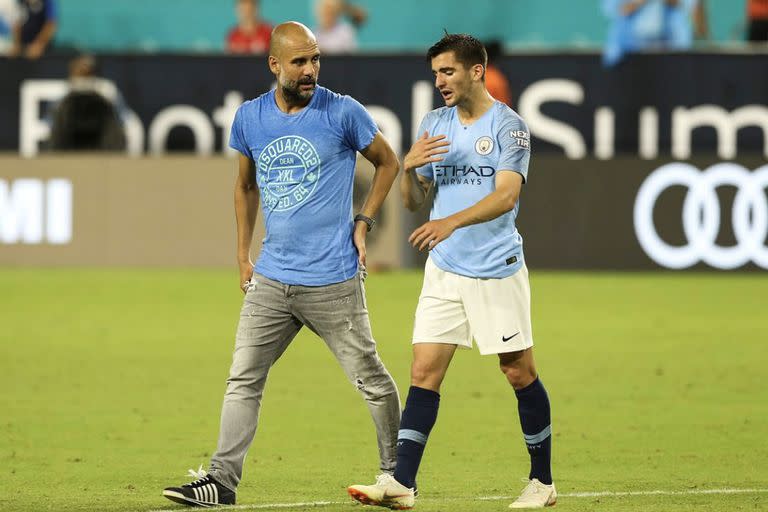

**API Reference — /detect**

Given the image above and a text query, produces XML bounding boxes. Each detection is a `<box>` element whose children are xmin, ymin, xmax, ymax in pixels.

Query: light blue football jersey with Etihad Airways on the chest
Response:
<box><xmin>416</xmin><ymin>101</ymin><xmax>531</xmax><ymax>278</ymax></box>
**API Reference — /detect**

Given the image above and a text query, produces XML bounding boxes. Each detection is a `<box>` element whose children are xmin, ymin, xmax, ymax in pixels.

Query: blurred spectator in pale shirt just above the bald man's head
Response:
<box><xmin>314</xmin><ymin>0</ymin><xmax>368</xmax><ymax>54</ymax></box>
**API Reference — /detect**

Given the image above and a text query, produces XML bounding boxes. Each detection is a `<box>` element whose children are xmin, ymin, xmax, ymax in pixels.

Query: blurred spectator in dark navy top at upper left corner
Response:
<box><xmin>10</xmin><ymin>0</ymin><xmax>58</xmax><ymax>59</ymax></box>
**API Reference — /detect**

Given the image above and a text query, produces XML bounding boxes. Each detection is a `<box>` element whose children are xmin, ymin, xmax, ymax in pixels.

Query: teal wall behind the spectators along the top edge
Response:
<box><xmin>52</xmin><ymin>0</ymin><xmax>744</xmax><ymax>51</ymax></box>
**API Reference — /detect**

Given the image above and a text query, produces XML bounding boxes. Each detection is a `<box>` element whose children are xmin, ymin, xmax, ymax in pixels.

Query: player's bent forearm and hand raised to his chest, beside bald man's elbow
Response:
<box><xmin>400</xmin><ymin>131</ymin><xmax>450</xmax><ymax>212</ymax></box>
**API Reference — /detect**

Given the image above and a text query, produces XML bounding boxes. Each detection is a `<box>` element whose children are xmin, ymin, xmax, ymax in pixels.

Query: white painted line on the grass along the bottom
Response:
<box><xmin>148</xmin><ymin>488</ymin><xmax>768</xmax><ymax>512</ymax></box>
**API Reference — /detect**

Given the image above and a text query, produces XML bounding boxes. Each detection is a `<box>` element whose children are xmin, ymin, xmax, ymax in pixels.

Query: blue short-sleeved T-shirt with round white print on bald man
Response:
<box><xmin>229</xmin><ymin>86</ymin><xmax>378</xmax><ymax>286</ymax></box>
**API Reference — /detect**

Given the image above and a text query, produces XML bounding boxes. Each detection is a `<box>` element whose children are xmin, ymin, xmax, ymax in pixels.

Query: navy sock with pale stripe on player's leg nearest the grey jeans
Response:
<box><xmin>394</xmin><ymin>386</ymin><xmax>440</xmax><ymax>489</ymax></box>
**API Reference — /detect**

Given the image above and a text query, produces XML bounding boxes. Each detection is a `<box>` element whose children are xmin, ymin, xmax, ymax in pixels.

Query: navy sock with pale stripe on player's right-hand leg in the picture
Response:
<box><xmin>515</xmin><ymin>377</ymin><xmax>552</xmax><ymax>485</ymax></box>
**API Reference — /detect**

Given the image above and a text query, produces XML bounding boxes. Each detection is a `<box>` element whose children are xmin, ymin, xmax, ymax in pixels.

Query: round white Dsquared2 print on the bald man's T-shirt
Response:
<box><xmin>257</xmin><ymin>135</ymin><xmax>320</xmax><ymax>211</ymax></box>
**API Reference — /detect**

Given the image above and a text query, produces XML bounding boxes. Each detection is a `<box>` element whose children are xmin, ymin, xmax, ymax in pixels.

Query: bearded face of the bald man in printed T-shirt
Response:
<box><xmin>275</xmin><ymin>39</ymin><xmax>320</xmax><ymax>103</ymax></box>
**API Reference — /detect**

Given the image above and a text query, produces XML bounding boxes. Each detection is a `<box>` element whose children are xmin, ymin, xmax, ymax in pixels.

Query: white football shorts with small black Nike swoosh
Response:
<box><xmin>413</xmin><ymin>258</ymin><xmax>533</xmax><ymax>355</ymax></box>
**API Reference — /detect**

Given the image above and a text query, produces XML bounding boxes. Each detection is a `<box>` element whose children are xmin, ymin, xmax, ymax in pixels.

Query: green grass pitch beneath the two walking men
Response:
<box><xmin>0</xmin><ymin>269</ymin><xmax>768</xmax><ymax>512</ymax></box>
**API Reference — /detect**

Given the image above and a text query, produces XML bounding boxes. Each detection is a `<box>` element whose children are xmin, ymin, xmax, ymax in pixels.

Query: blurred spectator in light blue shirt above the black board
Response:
<box><xmin>603</xmin><ymin>0</ymin><xmax>701</xmax><ymax>66</ymax></box>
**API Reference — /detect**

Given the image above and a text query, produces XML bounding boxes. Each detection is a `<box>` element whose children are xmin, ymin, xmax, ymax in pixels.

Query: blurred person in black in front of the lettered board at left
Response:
<box><xmin>50</xmin><ymin>55</ymin><xmax>127</xmax><ymax>151</ymax></box>
